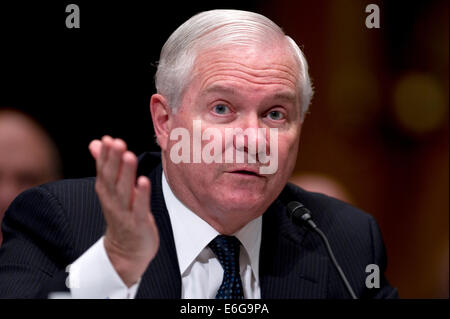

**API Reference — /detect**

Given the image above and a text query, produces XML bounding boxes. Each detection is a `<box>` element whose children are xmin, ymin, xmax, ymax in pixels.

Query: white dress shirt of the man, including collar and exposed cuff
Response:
<box><xmin>68</xmin><ymin>173</ymin><xmax>262</xmax><ymax>299</ymax></box>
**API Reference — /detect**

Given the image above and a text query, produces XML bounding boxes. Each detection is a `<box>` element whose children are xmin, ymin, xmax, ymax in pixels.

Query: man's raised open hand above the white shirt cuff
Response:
<box><xmin>89</xmin><ymin>136</ymin><xmax>159</xmax><ymax>287</ymax></box>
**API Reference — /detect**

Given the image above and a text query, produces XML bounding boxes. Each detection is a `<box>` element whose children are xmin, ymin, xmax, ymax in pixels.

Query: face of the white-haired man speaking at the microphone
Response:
<box><xmin>162</xmin><ymin>42</ymin><xmax>301</xmax><ymax>232</ymax></box>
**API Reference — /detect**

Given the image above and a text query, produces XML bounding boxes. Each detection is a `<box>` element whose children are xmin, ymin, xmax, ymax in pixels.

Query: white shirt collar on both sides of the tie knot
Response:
<box><xmin>162</xmin><ymin>172</ymin><xmax>262</xmax><ymax>280</ymax></box>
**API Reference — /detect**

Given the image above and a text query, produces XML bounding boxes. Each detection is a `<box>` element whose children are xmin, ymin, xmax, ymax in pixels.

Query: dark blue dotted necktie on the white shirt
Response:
<box><xmin>208</xmin><ymin>235</ymin><xmax>244</xmax><ymax>299</ymax></box>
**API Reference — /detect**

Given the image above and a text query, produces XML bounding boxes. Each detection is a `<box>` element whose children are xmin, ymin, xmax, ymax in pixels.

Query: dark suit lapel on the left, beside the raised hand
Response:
<box><xmin>136</xmin><ymin>164</ymin><xmax>181</xmax><ymax>299</ymax></box>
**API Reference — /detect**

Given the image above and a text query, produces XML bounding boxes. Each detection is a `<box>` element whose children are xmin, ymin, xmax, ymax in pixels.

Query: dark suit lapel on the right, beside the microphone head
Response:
<box><xmin>260</xmin><ymin>199</ymin><xmax>329</xmax><ymax>299</ymax></box>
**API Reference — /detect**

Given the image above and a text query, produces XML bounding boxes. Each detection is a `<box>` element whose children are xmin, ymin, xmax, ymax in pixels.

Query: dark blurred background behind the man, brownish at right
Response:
<box><xmin>0</xmin><ymin>0</ymin><xmax>449</xmax><ymax>298</ymax></box>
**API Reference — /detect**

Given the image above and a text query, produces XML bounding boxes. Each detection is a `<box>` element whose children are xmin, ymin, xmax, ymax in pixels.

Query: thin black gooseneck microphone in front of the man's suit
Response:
<box><xmin>287</xmin><ymin>202</ymin><xmax>358</xmax><ymax>299</ymax></box>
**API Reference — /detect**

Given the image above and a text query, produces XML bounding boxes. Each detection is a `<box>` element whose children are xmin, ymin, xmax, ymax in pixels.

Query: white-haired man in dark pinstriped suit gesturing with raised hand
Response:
<box><xmin>0</xmin><ymin>10</ymin><xmax>396</xmax><ymax>298</ymax></box>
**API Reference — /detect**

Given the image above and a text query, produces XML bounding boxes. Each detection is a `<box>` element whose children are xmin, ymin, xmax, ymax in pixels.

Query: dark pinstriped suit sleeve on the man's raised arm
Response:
<box><xmin>0</xmin><ymin>187</ymin><xmax>73</xmax><ymax>298</ymax></box>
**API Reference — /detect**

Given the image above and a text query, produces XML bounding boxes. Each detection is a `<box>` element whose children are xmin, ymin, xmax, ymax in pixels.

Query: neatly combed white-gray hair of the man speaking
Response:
<box><xmin>155</xmin><ymin>10</ymin><xmax>313</xmax><ymax>119</ymax></box>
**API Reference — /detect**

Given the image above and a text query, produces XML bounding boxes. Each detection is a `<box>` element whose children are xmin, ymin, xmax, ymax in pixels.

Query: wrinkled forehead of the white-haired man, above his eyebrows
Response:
<box><xmin>193</xmin><ymin>44</ymin><xmax>300</xmax><ymax>94</ymax></box>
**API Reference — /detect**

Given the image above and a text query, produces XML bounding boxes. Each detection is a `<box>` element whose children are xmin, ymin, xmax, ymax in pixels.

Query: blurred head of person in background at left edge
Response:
<box><xmin>0</xmin><ymin>109</ymin><xmax>62</xmax><ymax>244</ymax></box>
